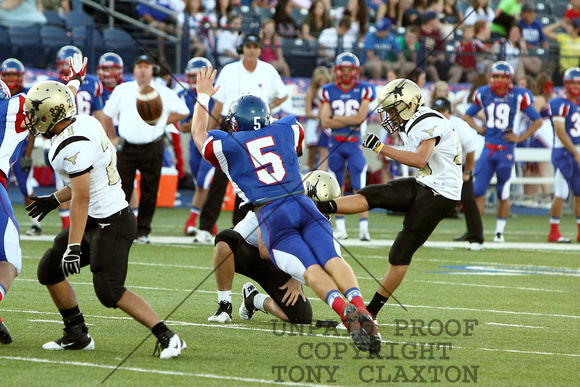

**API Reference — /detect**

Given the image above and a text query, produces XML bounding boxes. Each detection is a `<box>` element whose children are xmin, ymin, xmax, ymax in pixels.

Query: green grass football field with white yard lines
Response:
<box><xmin>0</xmin><ymin>206</ymin><xmax>580</xmax><ymax>386</ymax></box>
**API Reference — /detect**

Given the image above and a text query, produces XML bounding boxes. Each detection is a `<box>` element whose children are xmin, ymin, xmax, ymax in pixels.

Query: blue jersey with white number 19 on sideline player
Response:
<box><xmin>465</xmin><ymin>86</ymin><xmax>541</xmax><ymax>149</ymax></box>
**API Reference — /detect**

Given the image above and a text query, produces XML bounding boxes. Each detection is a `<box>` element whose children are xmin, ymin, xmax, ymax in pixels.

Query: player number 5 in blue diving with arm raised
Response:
<box><xmin>191</xmin><ymin>67</ymin><xmax>381</xmax><ymax>353</ymax></box>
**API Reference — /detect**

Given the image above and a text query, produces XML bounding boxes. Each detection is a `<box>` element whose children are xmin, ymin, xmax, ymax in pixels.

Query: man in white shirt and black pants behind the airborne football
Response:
<box><xmin>103</xmin><ymin>55</ymin><xmax>189</xmax><ymax>244</ymax></box>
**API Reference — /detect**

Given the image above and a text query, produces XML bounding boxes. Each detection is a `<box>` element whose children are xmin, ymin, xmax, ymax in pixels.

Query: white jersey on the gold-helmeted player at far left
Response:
<box><xmin>48</xmin><ymin>115</ymin><xmax>128</xmax><ymax>218</ymax></box>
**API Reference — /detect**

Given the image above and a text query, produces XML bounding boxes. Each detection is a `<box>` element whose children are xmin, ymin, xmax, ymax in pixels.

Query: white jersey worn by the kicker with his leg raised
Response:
<box><xmin>399</xmin><ymin>107</ymin><xmax>463</xmax><ymax>200</ymax></box>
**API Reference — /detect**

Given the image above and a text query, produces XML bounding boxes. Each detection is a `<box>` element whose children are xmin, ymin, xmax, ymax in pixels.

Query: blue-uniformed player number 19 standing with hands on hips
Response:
<box><xmin>463</xmin><ymin>61</ymin><xmax>542</xmax><ymax>242</ymax></box>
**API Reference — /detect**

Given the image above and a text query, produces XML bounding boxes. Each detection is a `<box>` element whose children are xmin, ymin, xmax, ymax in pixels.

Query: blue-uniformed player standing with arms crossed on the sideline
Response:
<box><xmin>319</xmin><ymin>52</ymin><xmax>375</xmax><ymax>241</ymax></box>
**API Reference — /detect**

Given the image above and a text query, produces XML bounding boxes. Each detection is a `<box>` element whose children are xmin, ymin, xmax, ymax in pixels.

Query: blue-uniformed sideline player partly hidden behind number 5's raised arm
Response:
<box><xmin>178</xmin><ymin>56</ymin><xmax>217</xmax><ymax>235</ymax></box>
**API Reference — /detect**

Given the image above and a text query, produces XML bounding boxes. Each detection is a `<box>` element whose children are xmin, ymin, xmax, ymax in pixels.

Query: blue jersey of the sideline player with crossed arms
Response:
<box><xmin>318</xmin><ymin>81</ymin><xmax>375</xmax><ymax>136</ymax></box>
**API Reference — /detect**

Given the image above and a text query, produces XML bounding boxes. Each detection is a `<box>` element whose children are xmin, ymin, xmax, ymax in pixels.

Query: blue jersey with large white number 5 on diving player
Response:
<box><xmin>202</xmin><ymin>116</ymin><xmax>304</xmax><ymax>208</ymax></box>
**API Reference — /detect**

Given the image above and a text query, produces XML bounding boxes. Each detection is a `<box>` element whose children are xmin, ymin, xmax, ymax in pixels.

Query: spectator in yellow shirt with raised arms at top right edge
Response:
<box><xmin>544</xmin><ymin>19</ymin><xmax>580</xmax><ymax>73</ymax></box>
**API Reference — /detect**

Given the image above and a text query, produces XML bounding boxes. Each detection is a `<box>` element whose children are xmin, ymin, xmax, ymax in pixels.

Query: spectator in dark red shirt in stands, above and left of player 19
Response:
<box><xmin>449</xmin><ymin>20</ymin><xmax>493</xmax><ymax>84</ymax></box>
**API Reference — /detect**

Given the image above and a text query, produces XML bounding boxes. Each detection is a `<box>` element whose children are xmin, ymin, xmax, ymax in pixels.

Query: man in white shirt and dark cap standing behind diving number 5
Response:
<box><xmin>194</xmin><ymin>34</ymin><xmax>288</xmax><ymax>244</ymax></box>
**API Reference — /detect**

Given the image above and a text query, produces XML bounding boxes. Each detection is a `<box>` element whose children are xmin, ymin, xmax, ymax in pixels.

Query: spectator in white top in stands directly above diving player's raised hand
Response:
<box><xmin>177</xmin><ymin>0</ymin><xmax>217</xmax><ymax>57</ymax></box>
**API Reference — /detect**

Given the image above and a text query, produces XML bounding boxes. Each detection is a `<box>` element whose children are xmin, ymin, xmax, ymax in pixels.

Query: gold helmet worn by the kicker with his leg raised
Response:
<box><xmin>377</xmin><ymin>79</ymin><xmax>424</xmax><ymax>133</ymax></box>
